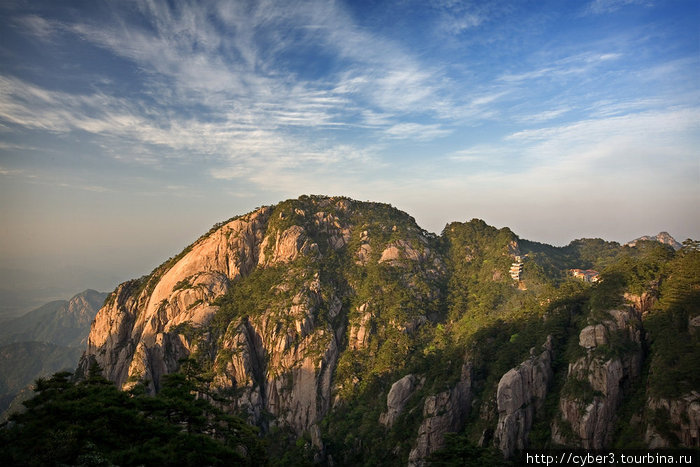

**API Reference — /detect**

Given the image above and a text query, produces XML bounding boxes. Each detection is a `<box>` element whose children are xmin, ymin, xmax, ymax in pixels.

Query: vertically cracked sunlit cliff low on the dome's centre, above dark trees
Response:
<box><xmin>190</xmin><ymin>272</ymin><xmax>342</xmax><ymax>439</ymax></box>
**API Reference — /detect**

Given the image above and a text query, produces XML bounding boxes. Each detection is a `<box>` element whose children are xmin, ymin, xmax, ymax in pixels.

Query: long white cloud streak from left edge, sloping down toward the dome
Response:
<box><xmin>0</xmin><ymin>73</ymin><xmax>350</xmax><ymax>176</ymax></box>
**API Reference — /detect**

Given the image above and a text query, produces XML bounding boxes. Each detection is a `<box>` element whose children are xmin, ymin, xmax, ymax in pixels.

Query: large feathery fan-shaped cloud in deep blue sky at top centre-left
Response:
<box><xmin>65</xmin><ymin>1</ymin><xmax>448</xmax><ymax>122</ymax></box>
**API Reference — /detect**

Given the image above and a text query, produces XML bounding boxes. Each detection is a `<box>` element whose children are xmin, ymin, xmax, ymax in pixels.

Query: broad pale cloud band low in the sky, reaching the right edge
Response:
<box><xmin>442</xmin><ymin>107</ymin><xmax>700</xmax><ymax>185</ymax></box>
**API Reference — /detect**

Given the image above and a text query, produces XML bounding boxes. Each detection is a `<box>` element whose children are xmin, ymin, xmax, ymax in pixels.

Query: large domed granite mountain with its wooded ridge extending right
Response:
<box><xmin>78</xmin><ymin>196</ymin><xmax>700</xmax><ymax>466</ymax></box>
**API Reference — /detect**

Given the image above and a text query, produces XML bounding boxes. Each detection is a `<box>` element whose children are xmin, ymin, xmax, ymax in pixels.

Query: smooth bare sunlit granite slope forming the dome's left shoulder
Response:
<box><xmin>80</xmin><ymin>208</ymin><xmax>270</xmax><ymax>390</ymax></box>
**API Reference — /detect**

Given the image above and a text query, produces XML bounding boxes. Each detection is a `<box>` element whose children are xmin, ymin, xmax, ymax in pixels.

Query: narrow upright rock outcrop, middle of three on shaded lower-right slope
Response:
<box><xmin>494</xmin><ymin>336</ymin><xmax>552</xmax><ymax>457</ymax></box>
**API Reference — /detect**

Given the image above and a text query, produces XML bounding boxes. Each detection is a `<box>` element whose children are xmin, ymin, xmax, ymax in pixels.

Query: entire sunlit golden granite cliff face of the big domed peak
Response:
<box><xmin>81</xmin><ymin>199</ymin><xmax>443</xmax><ymax>442</ymax></box>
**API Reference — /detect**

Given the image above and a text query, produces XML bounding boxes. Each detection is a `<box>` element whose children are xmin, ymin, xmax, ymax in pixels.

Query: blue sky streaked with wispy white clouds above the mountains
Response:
<box><xmin>0</xmin><ymin>0</ymin><xmax>700</xmax><ymax>308</ymax></box>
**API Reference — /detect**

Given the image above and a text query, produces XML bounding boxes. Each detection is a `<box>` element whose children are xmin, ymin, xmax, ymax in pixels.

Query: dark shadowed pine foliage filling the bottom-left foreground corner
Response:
<box><xmin>0</xmin><ymin>367</ymin><xmax>266</xmax><ymax>466</ymax></box>
